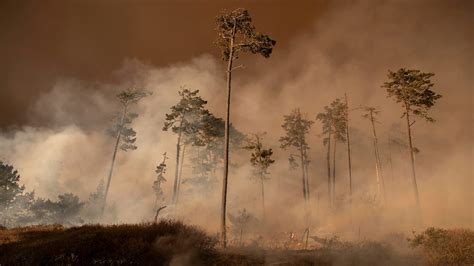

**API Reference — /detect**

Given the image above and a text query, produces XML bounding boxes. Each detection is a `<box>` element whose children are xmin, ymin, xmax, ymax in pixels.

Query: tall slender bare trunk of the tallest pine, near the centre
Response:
<box><xmin>221</xmin><ymin>21</ymin><xmax>236</xmax><ymax>248</ymax></box>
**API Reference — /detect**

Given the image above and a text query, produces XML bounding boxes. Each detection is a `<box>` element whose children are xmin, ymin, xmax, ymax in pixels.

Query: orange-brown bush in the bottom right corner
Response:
<box><xmin>408</xmin><ymin>227</ymin><xmax>474</xmax><ymax>265</ymax></box>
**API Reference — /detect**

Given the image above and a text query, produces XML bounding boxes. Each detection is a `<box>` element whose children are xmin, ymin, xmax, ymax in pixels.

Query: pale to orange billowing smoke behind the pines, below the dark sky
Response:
<box><xmin>0</xmin><ymin>1</ymin><xmax>474</xmax><ymax>241</ymax></box>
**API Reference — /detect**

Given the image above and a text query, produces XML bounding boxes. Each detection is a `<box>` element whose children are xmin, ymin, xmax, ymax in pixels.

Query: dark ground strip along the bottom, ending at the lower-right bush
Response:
<box><xmin>0</xmin><ymin>221</ymin><xmax>436</xmax><ymax>265</ymax></box>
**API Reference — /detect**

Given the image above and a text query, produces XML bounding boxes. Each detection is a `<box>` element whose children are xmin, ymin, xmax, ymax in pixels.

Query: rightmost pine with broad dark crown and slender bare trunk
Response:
<box><xmin>382</xmin><ymin>68</ymin><xmax>441</xmax><ymax>215</ymax></box>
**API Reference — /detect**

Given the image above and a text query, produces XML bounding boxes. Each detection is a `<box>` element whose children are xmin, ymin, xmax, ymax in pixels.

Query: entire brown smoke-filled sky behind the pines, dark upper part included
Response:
<box><xmin>0</xmin><ymin>0</ymin><xmax>474</xmax><ymax>230</ymax></box>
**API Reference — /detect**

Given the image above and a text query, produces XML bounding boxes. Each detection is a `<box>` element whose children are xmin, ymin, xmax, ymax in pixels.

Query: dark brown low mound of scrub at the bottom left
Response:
<box><xmin>0</xmin><ymin>221</ymin><xmax>216</xmax><ymax>265</ymax></box>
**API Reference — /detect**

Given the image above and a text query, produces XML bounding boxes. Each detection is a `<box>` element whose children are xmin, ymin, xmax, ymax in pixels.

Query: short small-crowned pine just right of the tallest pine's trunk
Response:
<box><xmin>244</xmin><ymin>133</ymin><xmax>275</xmax><ymax>220</ymax></box>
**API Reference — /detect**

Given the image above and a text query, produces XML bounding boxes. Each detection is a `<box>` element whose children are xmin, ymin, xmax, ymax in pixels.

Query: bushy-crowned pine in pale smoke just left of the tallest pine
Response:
<box><xmin>163</xmin><ymin>89</ymin><xmax>207</xmax><ymax>204</ymax></box>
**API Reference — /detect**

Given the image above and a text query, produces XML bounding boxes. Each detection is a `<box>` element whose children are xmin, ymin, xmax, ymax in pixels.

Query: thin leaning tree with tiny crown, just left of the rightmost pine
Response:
<box><xmin>362</xmin><ymin>107</ymin><xmax>386</xmax><ymax>202</ymax></box>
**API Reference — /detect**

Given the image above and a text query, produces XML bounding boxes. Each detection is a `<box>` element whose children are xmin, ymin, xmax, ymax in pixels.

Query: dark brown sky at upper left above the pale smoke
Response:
<box><xmin>0</xmin><ymin>0</ymin><xmax>328</xmax><ymax>129</ymax></box>
